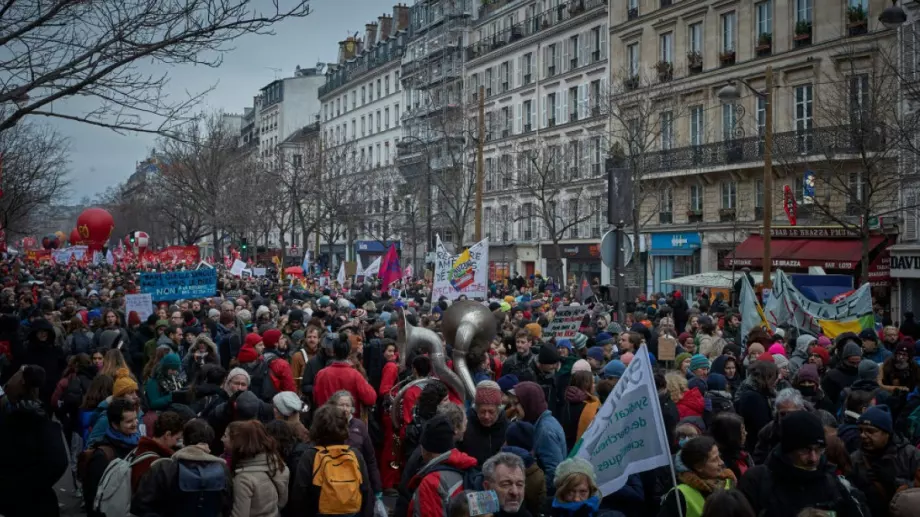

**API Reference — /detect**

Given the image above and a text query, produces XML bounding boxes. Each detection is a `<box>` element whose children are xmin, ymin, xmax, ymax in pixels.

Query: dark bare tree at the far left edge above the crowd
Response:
<box><xmin>0</xmin><ymin>119</ymin><xmax>70</xmax><ymax>234</ymax></box>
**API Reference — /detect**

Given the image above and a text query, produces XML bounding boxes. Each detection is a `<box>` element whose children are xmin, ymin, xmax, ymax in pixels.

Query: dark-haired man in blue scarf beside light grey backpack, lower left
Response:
<box><xmin>78</xmin><ymin>398</ymin><xmax>141</xmax><ymax>517</ymax></box>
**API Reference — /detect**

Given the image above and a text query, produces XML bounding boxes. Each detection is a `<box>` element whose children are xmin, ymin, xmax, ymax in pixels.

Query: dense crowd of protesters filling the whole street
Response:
<box><xmin>0</xmin><ymin>259</ymin><xmax>920</xmax><ymax>517</ymax></box>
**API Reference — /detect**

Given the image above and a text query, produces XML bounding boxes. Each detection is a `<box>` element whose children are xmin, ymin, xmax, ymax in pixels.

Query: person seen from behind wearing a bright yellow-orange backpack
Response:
<box><xmin>285</xmin><ymin>405</ymin><xmax>376</xmax><ymax>516</ymax></box>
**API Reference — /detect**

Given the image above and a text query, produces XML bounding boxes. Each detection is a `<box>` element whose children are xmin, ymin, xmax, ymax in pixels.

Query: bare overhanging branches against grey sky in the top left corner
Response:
<box><xmin>0</xmin><ymin>0</ymin><xmax>310</xmax><ymax>136</ymax></box>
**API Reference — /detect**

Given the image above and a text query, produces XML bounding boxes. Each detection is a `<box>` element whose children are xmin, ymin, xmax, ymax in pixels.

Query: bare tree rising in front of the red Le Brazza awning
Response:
<box><xmin>774</xmin><ymin>38</ymin><xmax>904</xmax><ymax>280</ymax></box>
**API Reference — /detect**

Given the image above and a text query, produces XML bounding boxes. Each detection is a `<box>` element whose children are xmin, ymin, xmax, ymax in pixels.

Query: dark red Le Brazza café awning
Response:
<box><xmin>721</xmin><ymin>226</ymin><xmax>894</xmax><ymax>288</ymax></box>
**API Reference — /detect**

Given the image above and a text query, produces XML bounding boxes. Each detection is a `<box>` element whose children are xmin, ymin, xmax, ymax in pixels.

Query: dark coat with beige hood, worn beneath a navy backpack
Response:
<box><xmin>131</xmin><ymin>446</ymin><xmax>233</xmax><ymax>517</ymax></box>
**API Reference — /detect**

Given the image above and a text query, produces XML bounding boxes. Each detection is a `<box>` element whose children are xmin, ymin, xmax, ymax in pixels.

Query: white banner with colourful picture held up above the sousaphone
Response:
<box><xmin>431</xmin><ymin>235</ymin><xmax>489</xmax><ymax>303</ymax></box>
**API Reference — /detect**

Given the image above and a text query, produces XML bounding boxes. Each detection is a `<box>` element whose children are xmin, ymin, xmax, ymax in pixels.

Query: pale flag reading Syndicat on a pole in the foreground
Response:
<box><xmin>571</xmin><ymin>345</ymin><xmax>671</xmax><ymax>496</ymax></box>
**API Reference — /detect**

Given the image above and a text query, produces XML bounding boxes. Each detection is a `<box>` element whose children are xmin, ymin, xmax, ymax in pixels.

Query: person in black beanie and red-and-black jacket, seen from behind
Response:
<box><xmin>406</xmin><ymin>416</ymin><xmax>482</xmax><ymax>517</ymax></box>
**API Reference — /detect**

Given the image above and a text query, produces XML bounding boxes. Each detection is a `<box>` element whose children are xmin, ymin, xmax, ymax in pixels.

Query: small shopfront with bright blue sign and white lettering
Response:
<box><xmin>649</xmin><ymin>232</ymin><xmax>702</xmax><ymax>293</ymax></box>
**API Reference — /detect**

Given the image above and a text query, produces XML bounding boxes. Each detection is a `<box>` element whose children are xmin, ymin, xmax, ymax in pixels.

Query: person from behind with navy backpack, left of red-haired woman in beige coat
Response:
<box><xmin>131</xmin><ymin>416</ymin><xmax>233</xmax><ymax>517</ymax></box>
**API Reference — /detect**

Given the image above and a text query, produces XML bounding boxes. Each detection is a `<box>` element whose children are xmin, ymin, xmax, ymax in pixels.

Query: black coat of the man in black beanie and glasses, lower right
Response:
<box><xmin>738</xmin><ymin>447</ymin><xmax>870</xmax><ymax>517</ymax></box>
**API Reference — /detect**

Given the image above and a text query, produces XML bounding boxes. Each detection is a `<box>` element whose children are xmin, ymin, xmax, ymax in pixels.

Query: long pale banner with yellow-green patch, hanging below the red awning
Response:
<box><xmin>764</xmin><ymin>270</ymin><xmax>872</xmax><ymax>335</ymax></box>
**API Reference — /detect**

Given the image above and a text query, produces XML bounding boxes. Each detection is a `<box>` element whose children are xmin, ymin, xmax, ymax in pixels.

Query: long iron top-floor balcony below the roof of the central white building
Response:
<box><xmin>466</xmin><ymin>0</ymin><xmax>607</xmax><ymax>60</ymax></box>
